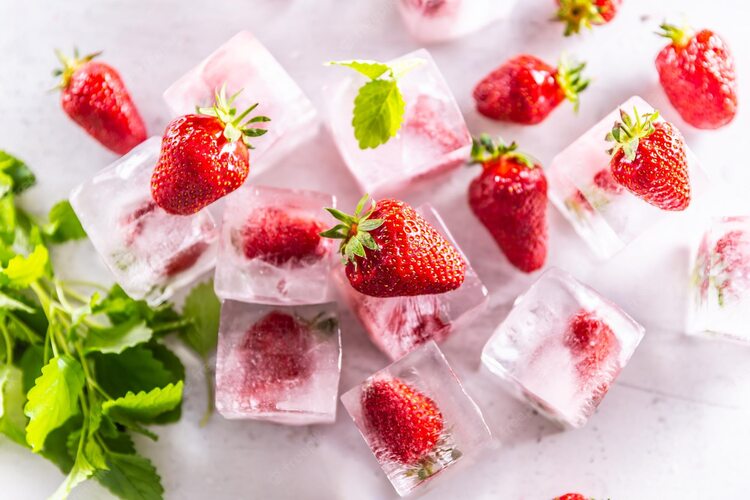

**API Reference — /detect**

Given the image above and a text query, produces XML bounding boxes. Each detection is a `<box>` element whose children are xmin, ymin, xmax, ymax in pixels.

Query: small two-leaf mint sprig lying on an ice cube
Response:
<box><xmin>328</xmin><ymin>59</ymin><xmax>425</xmax><ymax>149</ymax></box>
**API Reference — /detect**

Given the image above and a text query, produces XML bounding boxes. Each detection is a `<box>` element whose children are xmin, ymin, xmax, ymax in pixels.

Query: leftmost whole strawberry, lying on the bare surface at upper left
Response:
<box><xmin>54</xmin><ymin>50</ymin><xmax>146</xmax><ymax>154</ymax></box>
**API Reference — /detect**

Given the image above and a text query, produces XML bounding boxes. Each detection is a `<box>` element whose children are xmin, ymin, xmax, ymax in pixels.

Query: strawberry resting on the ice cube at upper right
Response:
<box><xmin>607</xmin><ymin>109</ymin><xmax>690</xmax><ymax>210</ymax></box>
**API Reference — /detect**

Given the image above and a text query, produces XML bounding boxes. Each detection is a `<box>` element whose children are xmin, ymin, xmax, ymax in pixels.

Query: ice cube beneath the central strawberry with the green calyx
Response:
<box><xmin>335</xmin><ymin>204</ymin><xmax>487</xmax><ymax>360</ymax></box>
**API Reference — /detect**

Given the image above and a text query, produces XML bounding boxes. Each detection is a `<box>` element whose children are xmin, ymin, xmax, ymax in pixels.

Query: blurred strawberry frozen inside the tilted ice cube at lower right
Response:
<box><xmin>563</xmin><ymin>309</ymin><xmax>620</xmax><ymax>378</ymax></box>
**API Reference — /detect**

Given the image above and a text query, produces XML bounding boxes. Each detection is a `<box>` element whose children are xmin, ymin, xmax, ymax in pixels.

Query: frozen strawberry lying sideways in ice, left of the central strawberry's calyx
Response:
<box><xmin>241</xmin><ymin>207</ymin><xmax>326</xmax><ymax>266</ymax></box>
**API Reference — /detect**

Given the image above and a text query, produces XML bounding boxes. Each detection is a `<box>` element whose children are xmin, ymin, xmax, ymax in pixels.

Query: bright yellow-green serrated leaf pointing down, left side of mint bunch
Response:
<box><xmin>24</xmin><ymin>354</ymin><xmax>84</xmax><ymax>452</ymax></box>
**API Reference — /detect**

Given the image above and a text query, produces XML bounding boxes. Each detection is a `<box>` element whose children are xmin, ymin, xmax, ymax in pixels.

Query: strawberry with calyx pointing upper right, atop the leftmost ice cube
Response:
<box><xmin>151</xmin><ymin>87</ymin><xmax>270</xmax><ymax>215</ymax></box>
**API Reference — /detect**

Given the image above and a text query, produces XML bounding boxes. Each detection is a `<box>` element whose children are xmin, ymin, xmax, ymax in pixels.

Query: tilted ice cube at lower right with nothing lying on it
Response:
<box><xmin>482</xmin><ymin>268</ymin><xmax>644</xmax><ymax>427</ymax></box>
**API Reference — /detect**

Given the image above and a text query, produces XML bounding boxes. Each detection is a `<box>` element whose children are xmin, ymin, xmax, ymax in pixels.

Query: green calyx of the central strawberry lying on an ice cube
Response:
<box><xmin>320</xmin><ymin>194</ymin><xmax>385</xmax><ymax>269</ymax></box>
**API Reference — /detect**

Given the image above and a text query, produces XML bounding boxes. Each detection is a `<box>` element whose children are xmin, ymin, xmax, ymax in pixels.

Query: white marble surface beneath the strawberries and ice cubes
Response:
<box><xmin>0</xmin><ymin>0</ymin><xmax>750</xmax><ymax>500</ymax></box>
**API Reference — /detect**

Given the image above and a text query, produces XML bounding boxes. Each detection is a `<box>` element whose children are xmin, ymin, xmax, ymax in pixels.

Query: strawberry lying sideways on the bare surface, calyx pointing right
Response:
<box><xmin>474</xmin><ymin>55</ymin><xmax>589</xmax><ymax>125</ymax></box>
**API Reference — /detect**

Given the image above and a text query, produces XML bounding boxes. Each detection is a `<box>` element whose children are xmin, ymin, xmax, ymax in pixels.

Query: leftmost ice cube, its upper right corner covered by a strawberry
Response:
<box><xmin>70</xmin><ymin>137</ymin><xmax>219</xmax><ymax>305</ymax></box>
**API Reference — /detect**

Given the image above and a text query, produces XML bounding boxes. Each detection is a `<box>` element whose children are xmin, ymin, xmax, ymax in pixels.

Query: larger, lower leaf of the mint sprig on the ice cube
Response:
<box><xmin>352</xmin><ymin>80</ymin><xmax>406</xmax><ymax>149</ymax></box>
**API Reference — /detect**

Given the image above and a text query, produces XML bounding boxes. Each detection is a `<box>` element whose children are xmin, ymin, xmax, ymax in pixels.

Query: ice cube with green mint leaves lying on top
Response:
<box><xmin>327</xmin><ymin>49</ymin><xmax>471</xmax><ymax>194</ymax></box>
